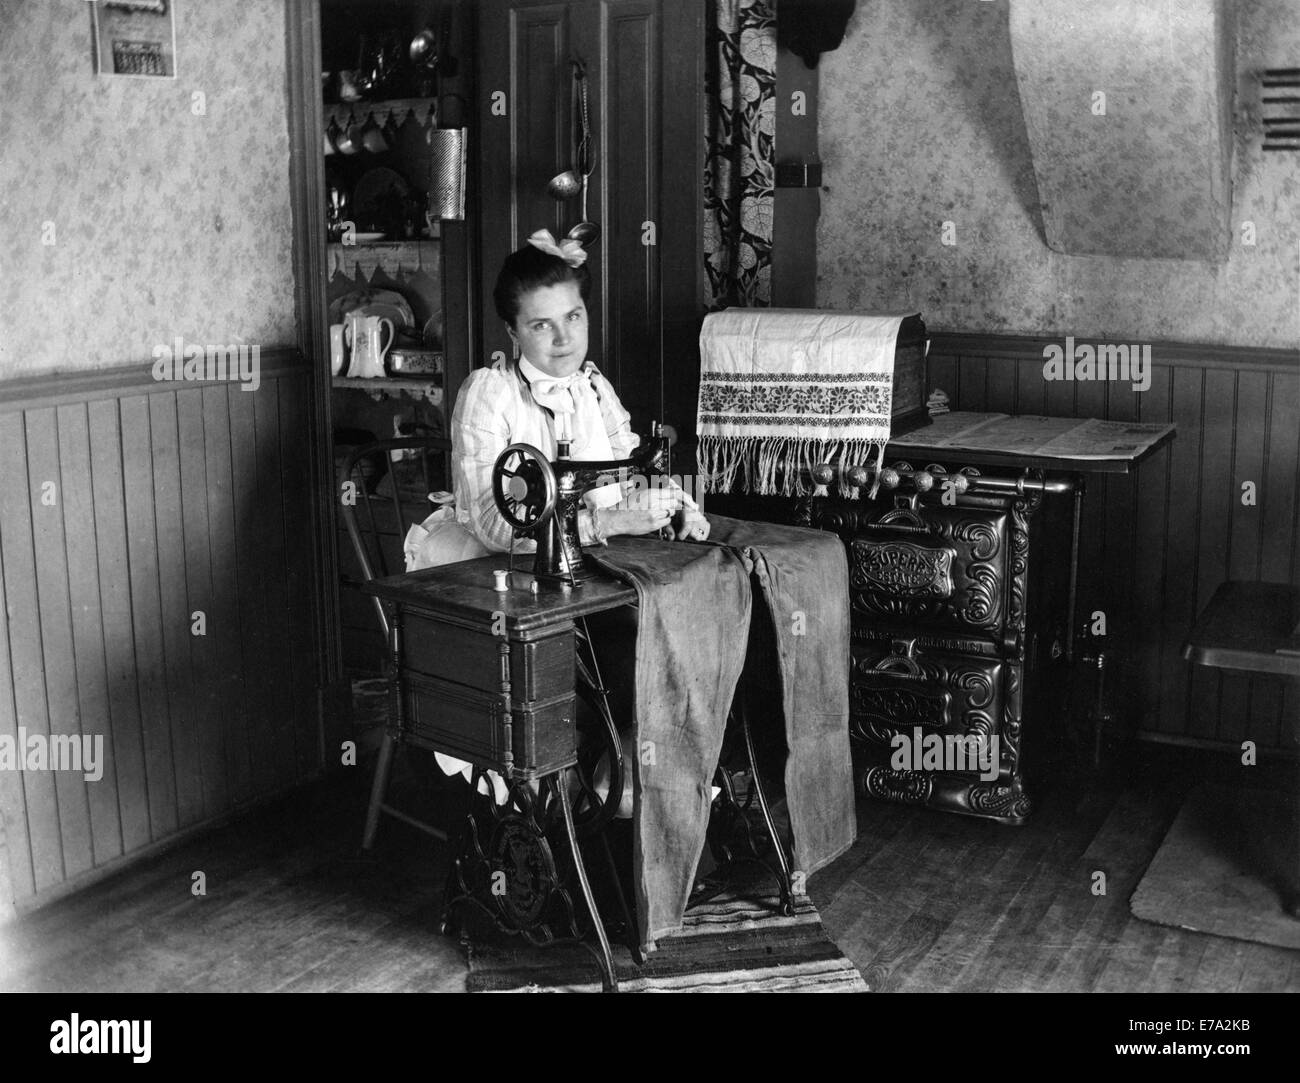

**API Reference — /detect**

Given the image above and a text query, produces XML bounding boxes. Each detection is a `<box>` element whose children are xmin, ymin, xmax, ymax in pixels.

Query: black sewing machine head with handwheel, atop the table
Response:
<box><xmin>491</xmin><ymin>424</ymin><xmax>671</xmax><ymax>585</ymax></box>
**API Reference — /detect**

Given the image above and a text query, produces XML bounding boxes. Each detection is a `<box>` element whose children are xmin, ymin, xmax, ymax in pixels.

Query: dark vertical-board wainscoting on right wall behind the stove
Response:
<box><xmin>930</xmin><ymin>333</ymin><xmax>1300</xmax><ymax>753</ymax></box>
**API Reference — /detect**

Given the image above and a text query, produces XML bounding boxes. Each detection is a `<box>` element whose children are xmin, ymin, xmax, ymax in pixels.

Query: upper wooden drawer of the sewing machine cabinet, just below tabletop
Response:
<box><xmin>402</xmin><ymin>611</ymin><xmax>575</xmax><ymax>702</ymax></box>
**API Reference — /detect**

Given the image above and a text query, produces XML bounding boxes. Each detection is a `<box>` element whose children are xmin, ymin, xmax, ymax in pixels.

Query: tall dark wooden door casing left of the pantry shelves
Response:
<box><xmin>285</xmin><ymin>0</ymin><xmax>343</xmax><ymax>702</ymax></box>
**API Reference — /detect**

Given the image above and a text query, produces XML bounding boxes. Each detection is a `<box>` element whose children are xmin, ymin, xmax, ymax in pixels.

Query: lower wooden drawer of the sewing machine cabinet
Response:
<box><xmin>406</xmin><ymin>672</ymin><xmax>577</xmax><ymax>777</ymax></box>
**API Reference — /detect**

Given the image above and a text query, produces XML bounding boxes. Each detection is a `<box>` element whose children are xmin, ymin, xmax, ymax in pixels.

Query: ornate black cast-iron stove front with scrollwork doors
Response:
<box><xmin>805</xmin><ymin>475</ymin><xmax>1060</xmax><ymax>823</ymax></box>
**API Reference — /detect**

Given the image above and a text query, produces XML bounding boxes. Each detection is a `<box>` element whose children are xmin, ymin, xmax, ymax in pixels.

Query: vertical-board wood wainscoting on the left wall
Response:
<box><xmin>0</xmin><ymin>350</ymin><xmax>322</xmax><ymax>913</ymax></box>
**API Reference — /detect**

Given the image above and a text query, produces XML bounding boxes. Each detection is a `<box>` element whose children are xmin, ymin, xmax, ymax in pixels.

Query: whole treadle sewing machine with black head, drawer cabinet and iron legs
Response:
<box><xmin>363</xmin><ymin>421</ymin><xmax>793</xmax><ymax>989</ymax></box>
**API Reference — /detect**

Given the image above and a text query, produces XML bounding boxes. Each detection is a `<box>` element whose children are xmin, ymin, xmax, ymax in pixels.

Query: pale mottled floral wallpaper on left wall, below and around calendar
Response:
<box><xmin>0</xmin><ymin>0</ymin><xmax>295</xmax><ymax>378</ymax></box>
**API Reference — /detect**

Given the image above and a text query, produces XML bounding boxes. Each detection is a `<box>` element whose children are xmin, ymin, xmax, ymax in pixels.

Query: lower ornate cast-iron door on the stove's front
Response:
<box><xmin>849</xmin><ymin>641</ymin><xmax>1014</xmax><ymax>774</ymax></box>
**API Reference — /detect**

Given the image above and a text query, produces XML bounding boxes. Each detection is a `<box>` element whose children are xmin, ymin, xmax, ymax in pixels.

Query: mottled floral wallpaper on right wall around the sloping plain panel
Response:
<box><xmin>818</xmin><ymin>0</ymin><xmax>1300</xmax><ymax>348</ymax></box>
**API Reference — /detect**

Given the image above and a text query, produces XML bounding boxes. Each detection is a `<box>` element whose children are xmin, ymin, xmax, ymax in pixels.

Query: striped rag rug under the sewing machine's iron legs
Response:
<box><xmin>468</xmin><ymin>892</ymin><xmax>868</xmax><ymax>993</ymax></box>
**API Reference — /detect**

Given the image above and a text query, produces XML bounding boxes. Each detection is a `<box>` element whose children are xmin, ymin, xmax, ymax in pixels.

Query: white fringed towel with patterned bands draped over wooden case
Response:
<box><xmin>698</xmin><ymin>308</ymin><xmax>914</xmax><ymax>497</ymax></box>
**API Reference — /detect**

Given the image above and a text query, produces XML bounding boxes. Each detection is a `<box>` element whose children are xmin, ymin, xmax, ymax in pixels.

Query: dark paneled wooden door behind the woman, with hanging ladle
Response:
<box><xmin>478</xmin><ymin>0</ymin><xmax>705</xmax><ymax>433</ymax></box>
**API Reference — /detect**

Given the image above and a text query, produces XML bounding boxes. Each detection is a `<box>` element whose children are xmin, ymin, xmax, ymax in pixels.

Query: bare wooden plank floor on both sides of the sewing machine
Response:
<box><xmin>0</xmin><ymin>748</ymin><xmax>1300</xmax><ymax>992</ymax></box>
